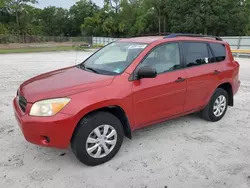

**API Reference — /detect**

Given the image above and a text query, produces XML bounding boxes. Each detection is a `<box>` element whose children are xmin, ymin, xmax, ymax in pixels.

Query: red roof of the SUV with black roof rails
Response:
<box><xmin>119</xmin><ymin>36</ymin><xmax>225</xmax><ymax>44</ymax></box>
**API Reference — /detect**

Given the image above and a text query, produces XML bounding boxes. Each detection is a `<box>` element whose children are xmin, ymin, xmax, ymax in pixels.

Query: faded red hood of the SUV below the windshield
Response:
<box><xmin>20</xmin><ymin>67</ymin><xmax>114</xmax><ymax>103</ymax></box>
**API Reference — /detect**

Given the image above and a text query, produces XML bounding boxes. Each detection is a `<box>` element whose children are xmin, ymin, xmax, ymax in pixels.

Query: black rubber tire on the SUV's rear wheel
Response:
<box><xmin>201</xmin><ymin>88</ymin><xmax>228</xmax><ymax>122</ymax></box>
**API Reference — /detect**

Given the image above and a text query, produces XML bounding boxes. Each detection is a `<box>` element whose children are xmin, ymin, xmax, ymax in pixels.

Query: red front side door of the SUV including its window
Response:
<box><xmin>132</xmin><ymin>43</ymin><xmax>186</xmax><ymax>128</ymax></box>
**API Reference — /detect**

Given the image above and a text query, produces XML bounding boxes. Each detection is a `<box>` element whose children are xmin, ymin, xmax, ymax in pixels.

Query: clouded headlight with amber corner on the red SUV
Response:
<box><xmin>30</xmin><ymin>98</ymin><xmax>70</xmax><ymax>116</ymax></box>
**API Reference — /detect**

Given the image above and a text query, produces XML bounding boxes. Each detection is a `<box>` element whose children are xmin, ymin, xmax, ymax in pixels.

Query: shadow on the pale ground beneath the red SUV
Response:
<box><xmin>20</xmin><ymin>113</ymin><xmax>204</xmax><ymax>168</ymax></box>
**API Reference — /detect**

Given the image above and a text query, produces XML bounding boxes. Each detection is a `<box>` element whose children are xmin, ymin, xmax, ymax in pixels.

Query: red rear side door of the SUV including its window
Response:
<box><xmin>182</xmin><ymin>42</ymin><xmax>222</xmax><ymax>112</ymax></box>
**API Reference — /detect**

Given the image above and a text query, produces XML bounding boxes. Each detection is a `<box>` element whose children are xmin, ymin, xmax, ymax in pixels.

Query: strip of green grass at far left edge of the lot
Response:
<box><xmin>0</xmin><ymin>46</ymin><xmax>84</xmax><ymax>54</ymax></box>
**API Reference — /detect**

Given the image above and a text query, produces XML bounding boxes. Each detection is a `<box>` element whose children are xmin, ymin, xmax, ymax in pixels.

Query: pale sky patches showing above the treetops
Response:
<box><xmin>35</xmin><ymin>0</ymin><xmax>103</xmax><ymax>8</ymax></box>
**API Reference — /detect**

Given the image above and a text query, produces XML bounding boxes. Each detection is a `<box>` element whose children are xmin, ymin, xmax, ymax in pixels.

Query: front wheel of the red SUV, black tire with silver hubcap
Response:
<box><xmin>71</xmin><ymin>111</ymin><xmax>124</xmax><ymax>166</ymax></box>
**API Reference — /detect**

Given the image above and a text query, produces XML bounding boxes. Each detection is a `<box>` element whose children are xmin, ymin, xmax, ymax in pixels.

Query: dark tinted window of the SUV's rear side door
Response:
<box><xmin>183</xmin><ymin>42</ymin><xmax>210</xmax><ymax>67</ymax></box>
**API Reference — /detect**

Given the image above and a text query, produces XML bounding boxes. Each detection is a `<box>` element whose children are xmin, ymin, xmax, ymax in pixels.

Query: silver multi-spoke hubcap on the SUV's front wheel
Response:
<box><xmin>86</xmin><ymin>125</ymin><xmax>117</xmax><ymax>158</ymax></box>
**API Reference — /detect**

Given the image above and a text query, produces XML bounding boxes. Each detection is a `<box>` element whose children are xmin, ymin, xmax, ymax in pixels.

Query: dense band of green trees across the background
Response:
<box><xmin>0</xmin><ymin>0</ymin><xmax>250</xmax><ymax>37</ymax></box>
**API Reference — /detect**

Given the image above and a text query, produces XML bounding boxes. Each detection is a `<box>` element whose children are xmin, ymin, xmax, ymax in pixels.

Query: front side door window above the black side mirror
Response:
<box><xmin>140</xmin><ymin>43</ymin><xmax>181</xmax><ymax>74</ymax></box>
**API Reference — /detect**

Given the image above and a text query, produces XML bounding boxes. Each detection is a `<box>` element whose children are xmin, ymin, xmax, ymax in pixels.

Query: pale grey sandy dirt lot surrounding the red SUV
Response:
<box><xmin>0</xmin><ymin>52</ymin><xmax>250</xmax><ymax>188</ymax></box>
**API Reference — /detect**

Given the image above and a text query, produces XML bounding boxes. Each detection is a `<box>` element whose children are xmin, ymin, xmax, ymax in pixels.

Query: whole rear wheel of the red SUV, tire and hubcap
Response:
<box><xmin>202</xmin><ymin>88</ymin><xmax>228</xmax><ymax>122</ymax></box>
